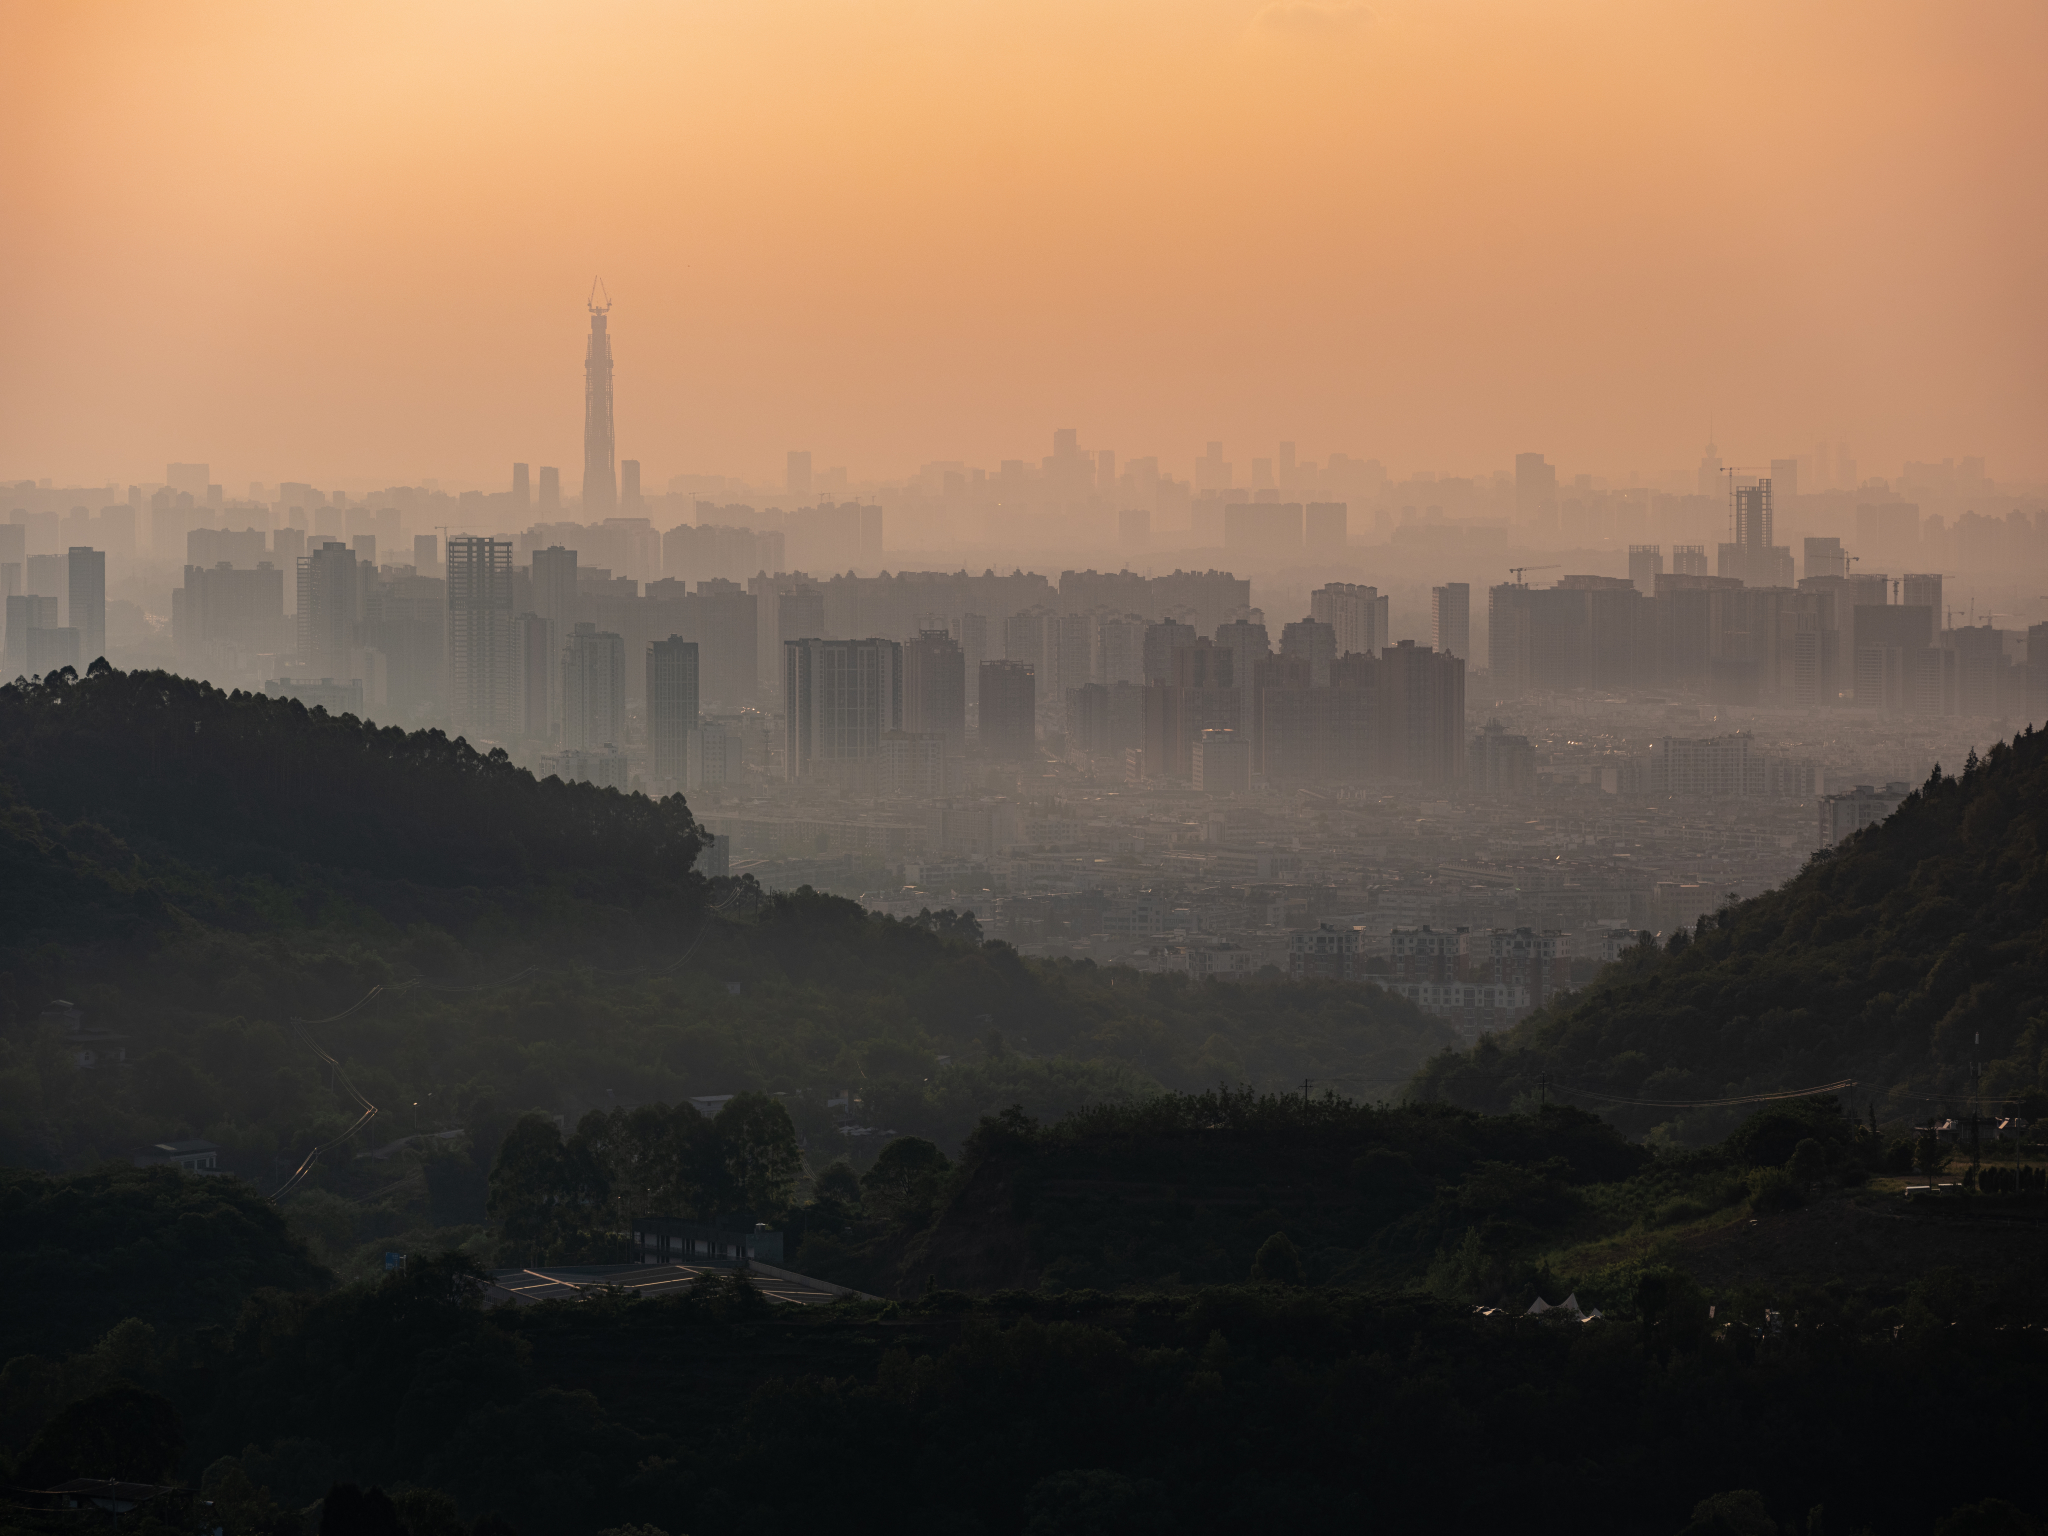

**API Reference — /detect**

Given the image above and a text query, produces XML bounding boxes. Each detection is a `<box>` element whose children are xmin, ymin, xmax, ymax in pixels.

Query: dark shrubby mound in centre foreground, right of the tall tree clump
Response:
<box><xmin>788</xmin><ymin>1092</ymin><xmax>1949</xmax><ymax>1309</ymax></box>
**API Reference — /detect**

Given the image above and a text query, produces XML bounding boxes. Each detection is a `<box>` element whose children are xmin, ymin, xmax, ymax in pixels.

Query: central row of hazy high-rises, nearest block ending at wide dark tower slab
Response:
<box><xmin>782</xmin><ymin>593</ymin><xmax>1464</xmax><ymax>795</ymax></box>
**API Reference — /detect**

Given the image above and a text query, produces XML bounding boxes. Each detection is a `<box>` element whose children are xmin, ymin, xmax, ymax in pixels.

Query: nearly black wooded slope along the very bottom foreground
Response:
<box><xmin>6</xmin><ymin>1257</ymin><xmax>2048</xmax><ymax>1536</ymax></box>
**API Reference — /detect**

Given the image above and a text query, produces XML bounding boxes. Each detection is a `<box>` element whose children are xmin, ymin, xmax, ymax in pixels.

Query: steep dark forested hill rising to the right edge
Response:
<box><xmin>1415</xmin><ymin>729</ymin><xmax>2048</xmax><ymax>1141</ymax></box>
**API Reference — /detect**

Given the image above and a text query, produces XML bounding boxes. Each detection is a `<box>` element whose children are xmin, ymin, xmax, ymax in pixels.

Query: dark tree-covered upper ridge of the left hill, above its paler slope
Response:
<box><xmin>0</xmin><ymin>668</ymin><xmax>702</xmax><ymax>946</ymax></box>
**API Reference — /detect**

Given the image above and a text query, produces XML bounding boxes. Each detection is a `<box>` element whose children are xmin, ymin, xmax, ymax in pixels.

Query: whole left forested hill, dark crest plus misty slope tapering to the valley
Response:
<box><xmin>0</xmin><ymin>672</ymin><xmax>1452</xmax><ymax>1187</ymax></box>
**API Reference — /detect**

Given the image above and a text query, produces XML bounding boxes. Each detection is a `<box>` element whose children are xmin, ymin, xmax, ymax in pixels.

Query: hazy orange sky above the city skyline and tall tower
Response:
<box><xmin>0</xmin><ymin>0</ymin><xmax>2048</xmax><ymax>492</ymax></box>
